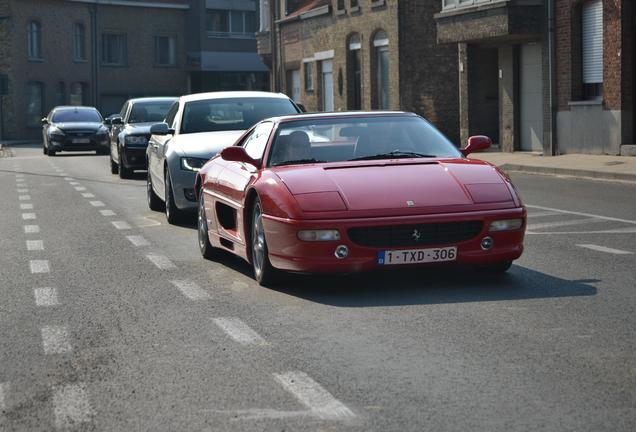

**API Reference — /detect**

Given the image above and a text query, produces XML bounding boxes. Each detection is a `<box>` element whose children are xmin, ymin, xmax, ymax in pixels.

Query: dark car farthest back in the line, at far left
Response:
<box><xmin>42</xmin><ymin>106</ymin><xmax>108</xmax><ymax>156</ymax></box>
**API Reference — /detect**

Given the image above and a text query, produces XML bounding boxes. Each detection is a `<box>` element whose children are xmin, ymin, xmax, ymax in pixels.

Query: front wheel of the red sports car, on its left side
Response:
<box><xmin>250</xmin><ymin>198</ymin><xmax>280</xmax><ymax>287</ymax></box>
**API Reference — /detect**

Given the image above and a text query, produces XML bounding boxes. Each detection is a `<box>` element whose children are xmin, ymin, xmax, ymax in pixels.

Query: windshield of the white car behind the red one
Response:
<box><xmin>181</xmin><ymin>97</ymin><xmax>298</xmax><ymax>134</ymax></box>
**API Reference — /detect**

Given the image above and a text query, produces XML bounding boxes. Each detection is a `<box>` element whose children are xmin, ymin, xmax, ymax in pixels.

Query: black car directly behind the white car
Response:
<box><xmin>110</xmin><ymin>97</ymin><xmax>177</xmax><ymax>178</ymax></box>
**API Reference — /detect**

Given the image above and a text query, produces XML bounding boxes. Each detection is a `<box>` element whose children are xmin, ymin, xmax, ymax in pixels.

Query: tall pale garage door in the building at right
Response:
<box><xmin>519</xmin><ymin>43</ymin><xmax>543</xmax><ymax>151</ymax></box>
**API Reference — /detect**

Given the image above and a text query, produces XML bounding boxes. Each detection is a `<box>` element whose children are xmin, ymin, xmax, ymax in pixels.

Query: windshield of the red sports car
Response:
<box><xmin>268</xmin><ymin>116</ymin><xmax>461</xmax><ymax>166</ymax></box>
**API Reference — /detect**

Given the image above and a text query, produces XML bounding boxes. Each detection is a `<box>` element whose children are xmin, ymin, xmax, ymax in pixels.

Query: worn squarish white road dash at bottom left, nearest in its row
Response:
<box><xmin>53</xmin><ymin>384</ymin><xmax>95</xmax><ymax>429</ymax></box>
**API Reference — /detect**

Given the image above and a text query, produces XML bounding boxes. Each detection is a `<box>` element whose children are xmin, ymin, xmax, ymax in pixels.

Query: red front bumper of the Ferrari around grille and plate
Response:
<box><xmin>263</xmin><ymin>208</ymin><xmax>526</xmax><ymax>273</ymax></box>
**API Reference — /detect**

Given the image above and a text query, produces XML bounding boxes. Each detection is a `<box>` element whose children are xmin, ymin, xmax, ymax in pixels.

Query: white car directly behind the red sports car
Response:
<box><xmin>147</xmin><ymin>91</ymin><xmax>300</xmax><ymax>223</ymax></box>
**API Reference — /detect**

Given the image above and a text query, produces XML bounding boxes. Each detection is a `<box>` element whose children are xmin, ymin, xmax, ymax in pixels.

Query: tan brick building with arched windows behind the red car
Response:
<box><xmin>257</xmin><ymin>0</ymin><xmax>459</xmax><ymax>144</ymax></box>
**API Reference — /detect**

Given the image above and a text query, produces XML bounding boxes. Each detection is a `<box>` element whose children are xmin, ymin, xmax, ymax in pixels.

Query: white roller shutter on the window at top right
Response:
<box><xmin>582</xmin><ymin>0</ymin><xmax>603</xmax><ymax>84</ymax></box>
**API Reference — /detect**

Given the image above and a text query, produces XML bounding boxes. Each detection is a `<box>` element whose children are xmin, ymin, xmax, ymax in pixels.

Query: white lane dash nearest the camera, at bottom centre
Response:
<box><xmin>274</xmin><ymin>371</ymin><xmax>355</xmax><ymax>420</ymax></box>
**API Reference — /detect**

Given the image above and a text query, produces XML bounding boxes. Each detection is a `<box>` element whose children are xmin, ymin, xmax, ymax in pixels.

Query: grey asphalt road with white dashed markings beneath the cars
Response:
<box><xmin>0</xmin><ymin>146</ymin><xmax>636</xmax><ymax>432</ymax></box>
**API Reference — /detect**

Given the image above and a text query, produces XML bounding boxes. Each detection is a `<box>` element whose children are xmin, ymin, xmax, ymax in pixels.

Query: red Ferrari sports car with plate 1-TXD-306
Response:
<box><xmin>195</xmin><ymin>112</ymin><xmax>526</xmax><ymax>285</ymax></box>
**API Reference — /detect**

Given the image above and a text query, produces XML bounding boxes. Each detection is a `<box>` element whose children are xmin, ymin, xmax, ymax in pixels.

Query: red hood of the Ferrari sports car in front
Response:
<box><xmin>274</xmin><ymin>159</ymin><xmax>515</xmax><ymax>212</ymax></box>
